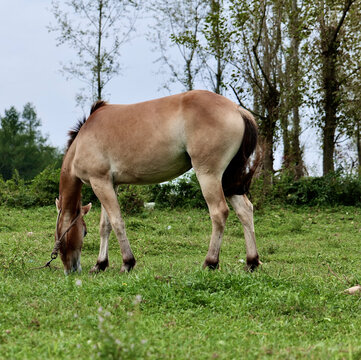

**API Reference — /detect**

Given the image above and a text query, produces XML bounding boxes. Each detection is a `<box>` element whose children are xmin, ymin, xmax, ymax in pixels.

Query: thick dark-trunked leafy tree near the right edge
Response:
<box><xmin>314</xmin><ymin>0</ymin><xmax>361</xmax><ymax>175</ymax></box>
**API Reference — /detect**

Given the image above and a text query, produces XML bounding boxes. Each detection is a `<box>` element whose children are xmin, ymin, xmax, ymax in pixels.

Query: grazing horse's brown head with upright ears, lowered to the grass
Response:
<box><xmin>55</xmin><ymin>199</ymin><xmax>91</xmax><ymax>275</ymax></box>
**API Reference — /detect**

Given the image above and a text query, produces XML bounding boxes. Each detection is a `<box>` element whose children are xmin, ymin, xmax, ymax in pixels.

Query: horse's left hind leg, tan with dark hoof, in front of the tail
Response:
<box><xmin>196</xmin><ymin>171</ymin><xmax>229</xmax><ymax>269</ymax></box>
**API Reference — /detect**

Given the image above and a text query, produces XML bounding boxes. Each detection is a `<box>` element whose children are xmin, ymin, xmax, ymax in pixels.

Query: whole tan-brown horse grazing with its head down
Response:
<box><xmin>52</xmin><ymin>91</ymin><xmax>260</xmax><ymax>274</ymax></box>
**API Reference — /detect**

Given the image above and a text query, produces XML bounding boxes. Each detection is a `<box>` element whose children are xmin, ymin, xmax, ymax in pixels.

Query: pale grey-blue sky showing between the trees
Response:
<box><xmin>0</xmin><ymin>0</ymin><xmax>321</xmax><ymax>174</ymax></box>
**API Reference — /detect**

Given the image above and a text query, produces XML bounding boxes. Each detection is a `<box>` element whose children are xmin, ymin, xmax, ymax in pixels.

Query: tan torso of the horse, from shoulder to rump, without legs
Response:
<box><xmin>73</xmin><ymin>91</ymin><xmax>243</xmax><ymax>184</ymax></box>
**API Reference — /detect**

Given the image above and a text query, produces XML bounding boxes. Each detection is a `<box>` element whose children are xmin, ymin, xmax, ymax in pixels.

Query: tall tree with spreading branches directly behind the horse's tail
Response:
<box><xmin>231</xmin><ymin>0</ymin><xmax>284</xmax><ymax>184</ymax></box>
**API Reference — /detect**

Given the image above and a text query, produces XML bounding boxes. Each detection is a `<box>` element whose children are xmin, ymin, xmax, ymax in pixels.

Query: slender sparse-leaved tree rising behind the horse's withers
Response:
<box><xmin>48</xmin><ymin>0</ymin><xmax>139</xmax><ymax>104</ymax></box>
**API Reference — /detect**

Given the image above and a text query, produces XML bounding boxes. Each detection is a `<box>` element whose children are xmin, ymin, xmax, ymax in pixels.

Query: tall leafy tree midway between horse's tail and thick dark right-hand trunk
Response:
<box><xmin>279</xmin><ymin>0</ymin><xmax>309</xmax><ymax>179</ymax></box>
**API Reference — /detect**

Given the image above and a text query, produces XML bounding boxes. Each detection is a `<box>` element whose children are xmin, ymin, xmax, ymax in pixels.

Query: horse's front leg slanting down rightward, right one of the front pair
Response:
<box><xmin>90</xmin><ymin>178</ymin><xmax>135</xmax><ymax>272</ymax></box>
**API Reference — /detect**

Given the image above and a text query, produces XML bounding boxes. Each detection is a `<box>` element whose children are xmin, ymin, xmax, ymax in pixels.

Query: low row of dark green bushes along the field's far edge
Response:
<box><xmin>0</xmin><ymin>167</ymin><xmax>361</xmax><ymax>208</ymax></box>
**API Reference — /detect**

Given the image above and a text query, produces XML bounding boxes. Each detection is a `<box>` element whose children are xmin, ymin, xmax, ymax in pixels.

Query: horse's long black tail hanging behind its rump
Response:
<box><xmin>222</xmin><ymin>108</ymin><xmax>261</xmax><ymax>196</ymax></box>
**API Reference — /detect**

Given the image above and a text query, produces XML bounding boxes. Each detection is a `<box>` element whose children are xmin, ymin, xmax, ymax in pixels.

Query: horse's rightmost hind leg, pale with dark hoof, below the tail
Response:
<box><xmin>227</xmin><ymin>195</ymin><xmax>261</xmax><ymax>271</ymax></box>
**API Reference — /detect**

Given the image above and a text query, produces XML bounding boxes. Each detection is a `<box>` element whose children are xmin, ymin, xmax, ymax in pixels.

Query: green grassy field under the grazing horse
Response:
<box><xmin>0</xmin><ymin>206</ymin><xmax>361</xmax><ymax>359</ymax></box>
